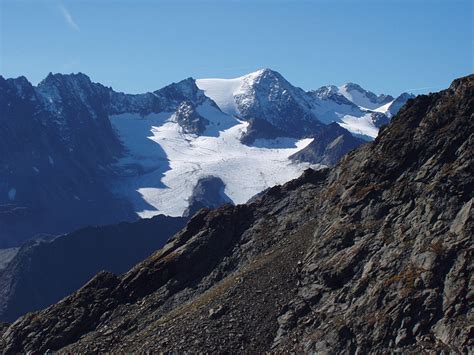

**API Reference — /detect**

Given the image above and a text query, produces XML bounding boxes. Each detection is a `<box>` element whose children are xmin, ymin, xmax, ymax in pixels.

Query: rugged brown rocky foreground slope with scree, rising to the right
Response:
<box><xmin>0</xmin><ymin>76</ymin><xmax>474</xmax><ymax>354</ymax></box>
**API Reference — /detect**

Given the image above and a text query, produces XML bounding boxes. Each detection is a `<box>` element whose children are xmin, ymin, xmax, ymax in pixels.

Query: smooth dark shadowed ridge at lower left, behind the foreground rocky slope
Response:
<box><xmin>0</xmin><ymin>215</ymin><xmax>187</xmax><ymax>321</ymax></box>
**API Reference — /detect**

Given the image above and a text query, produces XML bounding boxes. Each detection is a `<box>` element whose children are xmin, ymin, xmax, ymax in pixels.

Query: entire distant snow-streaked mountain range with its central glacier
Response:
<box><xmin>0</xmin><ymin>69</ymin><xmax>411</xmax><ymax>248</ymax></box>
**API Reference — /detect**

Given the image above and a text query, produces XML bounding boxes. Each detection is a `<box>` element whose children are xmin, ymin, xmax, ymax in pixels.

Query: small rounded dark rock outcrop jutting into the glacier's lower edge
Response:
<box><xmin>183</xmin><ymin>176</ymin><xmax>232</xmax><ymax>217</ymax></box>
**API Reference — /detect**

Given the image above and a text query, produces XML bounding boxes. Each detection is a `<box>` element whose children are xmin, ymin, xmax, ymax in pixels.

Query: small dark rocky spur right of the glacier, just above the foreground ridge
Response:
<box><xmin>290</xmin><ymin>123</ymin><xmax>365</xmax><ymax>166</ymax></box>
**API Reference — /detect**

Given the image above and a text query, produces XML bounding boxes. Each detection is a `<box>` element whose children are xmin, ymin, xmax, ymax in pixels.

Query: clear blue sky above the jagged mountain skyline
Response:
<box><xmin>0</xmin><ymin>0</ymin><xmax>474</xmax><ymax>95</ymax></box>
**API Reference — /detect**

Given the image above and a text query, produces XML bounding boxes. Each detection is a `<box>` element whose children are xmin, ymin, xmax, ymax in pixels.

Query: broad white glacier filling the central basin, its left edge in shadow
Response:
<box><xmin>110</xmin><ymin>105</ymin><xmax>320</xmax><ymax>218</ymax></box>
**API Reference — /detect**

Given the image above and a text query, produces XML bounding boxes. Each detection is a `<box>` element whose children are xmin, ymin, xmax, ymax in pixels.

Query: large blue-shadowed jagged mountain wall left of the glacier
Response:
<box><xmin>0</xmin><ymin>75</ymin><xmax>136</xmax><ymax>248</ymax></box>
